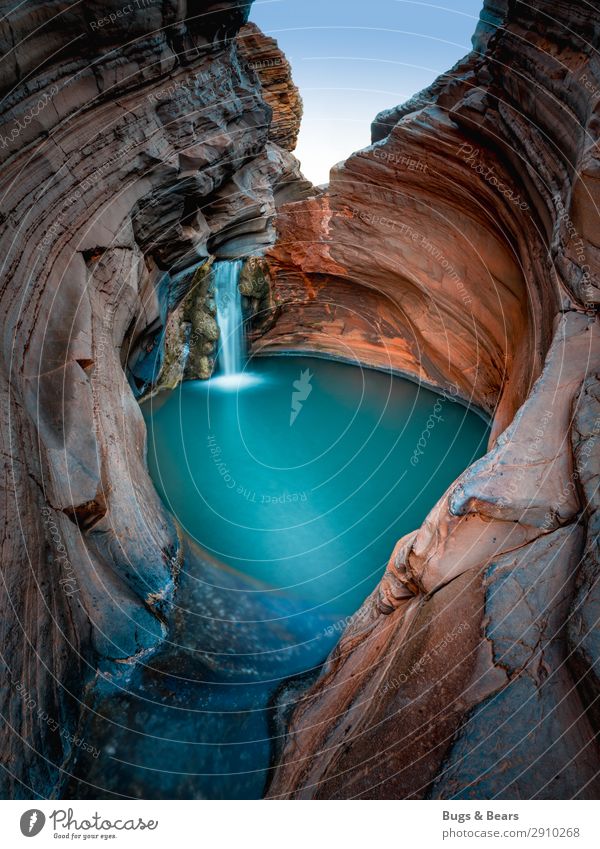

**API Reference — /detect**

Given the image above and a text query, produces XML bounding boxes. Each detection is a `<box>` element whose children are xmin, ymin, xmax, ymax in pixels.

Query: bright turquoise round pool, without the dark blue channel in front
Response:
<box><xmin>144</xmin><ymin>357</ymin><xmax>487</xmax><ymax>614</ymax></box>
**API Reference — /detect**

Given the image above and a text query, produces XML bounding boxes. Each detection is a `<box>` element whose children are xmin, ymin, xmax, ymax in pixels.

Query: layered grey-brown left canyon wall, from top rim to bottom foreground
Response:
<box><xmin>0</xmin><ymin>0</ymin><xmax>307</xmax><ymax>797</ymax></box>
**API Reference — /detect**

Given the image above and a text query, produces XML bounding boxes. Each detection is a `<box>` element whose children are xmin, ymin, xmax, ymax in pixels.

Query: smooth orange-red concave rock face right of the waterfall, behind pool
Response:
<box><xmin>260</xmin><ymin>102</ymin><xmax>558</xmax><ymax>432</ymax></box>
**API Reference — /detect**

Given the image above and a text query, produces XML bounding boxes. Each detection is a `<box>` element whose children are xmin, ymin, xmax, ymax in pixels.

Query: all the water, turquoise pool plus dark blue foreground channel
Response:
<box><xmin>69</xmin><ymin>357</ymin><xmax>487</xmax><ymax>799</ymax></box>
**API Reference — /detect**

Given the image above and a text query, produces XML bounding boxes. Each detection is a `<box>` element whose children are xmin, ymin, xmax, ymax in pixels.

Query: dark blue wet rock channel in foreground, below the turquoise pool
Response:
<box><xmin>64</xmin><ymin>541</ymin><xmax>337</xmax><ymax>799</ymax></box>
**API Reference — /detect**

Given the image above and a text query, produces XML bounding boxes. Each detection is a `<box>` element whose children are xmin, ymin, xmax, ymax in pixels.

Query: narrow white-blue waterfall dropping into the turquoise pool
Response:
<box><xmin>213</xmin><ymin>259</ymin><xmax>246</xmax><ymax>377</ymax></box>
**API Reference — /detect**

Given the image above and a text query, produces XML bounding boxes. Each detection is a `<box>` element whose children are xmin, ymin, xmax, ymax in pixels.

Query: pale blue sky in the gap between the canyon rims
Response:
<box><xmin>250</xmin><ymin>0</ymin><xmax>483</xmax><ymax>184</ymax></box>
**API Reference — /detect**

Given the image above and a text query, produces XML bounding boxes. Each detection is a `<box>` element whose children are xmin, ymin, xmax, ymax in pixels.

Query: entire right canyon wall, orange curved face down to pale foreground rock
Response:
<box><xmin>262</xmin><ymin>0</ymin><xmax>600</xmax><ymax>798</ymax></box>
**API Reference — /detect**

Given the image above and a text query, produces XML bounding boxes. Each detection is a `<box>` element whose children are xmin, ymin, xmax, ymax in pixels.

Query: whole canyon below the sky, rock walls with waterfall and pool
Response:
<box><xmin>0</xmin><ymin>0</ymin><xmax>600</xmax><ymax>800</ymax></box>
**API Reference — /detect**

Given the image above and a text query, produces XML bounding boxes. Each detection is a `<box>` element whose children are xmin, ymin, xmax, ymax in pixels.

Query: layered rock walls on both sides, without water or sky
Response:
<box><xmin>0</xmin><ymin>0</ymin><xmax>600</xmax><ymax>798</ymax></box>
